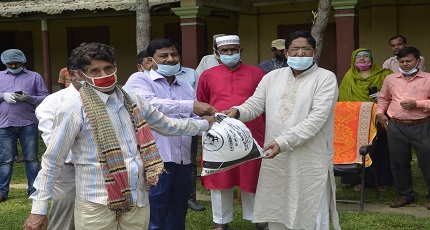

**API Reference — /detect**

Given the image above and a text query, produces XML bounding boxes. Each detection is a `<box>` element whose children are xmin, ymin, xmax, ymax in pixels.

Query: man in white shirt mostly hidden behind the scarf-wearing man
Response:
<box><xmin>36</xmin><ymin>59</ymin><xmax>82</xmax><ymax>230</ymax></box>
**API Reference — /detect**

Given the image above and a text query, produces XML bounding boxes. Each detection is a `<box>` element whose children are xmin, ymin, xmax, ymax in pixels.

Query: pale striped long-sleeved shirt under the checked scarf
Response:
<box><xmin>30</xmin><ymin>86</ymin><xmax>209</xmax><ymax>215</ymax></box>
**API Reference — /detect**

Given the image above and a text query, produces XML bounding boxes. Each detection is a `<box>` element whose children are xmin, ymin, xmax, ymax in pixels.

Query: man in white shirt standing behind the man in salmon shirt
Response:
<box><xmin>382</xmin><ymin>35</ymin><xmax>425</xmax><ymax>73</ymax></box>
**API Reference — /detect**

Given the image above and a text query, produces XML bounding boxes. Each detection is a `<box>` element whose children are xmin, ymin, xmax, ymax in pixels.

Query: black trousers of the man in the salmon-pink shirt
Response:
<box><xmin>387</xmin><ymin>122</ymin><xmax>430</xmax><ymax>201</ymax></box>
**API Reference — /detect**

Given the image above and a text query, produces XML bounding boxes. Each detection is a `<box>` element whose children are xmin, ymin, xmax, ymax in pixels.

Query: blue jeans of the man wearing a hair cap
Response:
<box><xmin>0</xmin><ymin>123</ymin><xmax>40</xmax><ymax>198</ymax></box>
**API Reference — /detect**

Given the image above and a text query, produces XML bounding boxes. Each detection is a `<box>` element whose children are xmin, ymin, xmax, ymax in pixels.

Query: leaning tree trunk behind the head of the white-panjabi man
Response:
<box><xmin>311</xmin><ymin>0</ymin><xmax>331</xmax><ymax>63</ymax></box>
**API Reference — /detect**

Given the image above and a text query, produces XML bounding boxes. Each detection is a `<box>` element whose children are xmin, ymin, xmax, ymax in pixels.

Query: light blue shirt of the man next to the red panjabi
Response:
<box><xmin>123</xmin><ymin>68</ymin><xmax>200</xmax><ymax>165</ymax></box>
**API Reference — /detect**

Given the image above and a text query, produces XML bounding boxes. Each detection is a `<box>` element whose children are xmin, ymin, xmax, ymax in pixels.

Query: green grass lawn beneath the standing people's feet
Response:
<box><xmin>0</xmin><ymin>137</ymin><xmax>430</xmax><ymax>230</ymax></box>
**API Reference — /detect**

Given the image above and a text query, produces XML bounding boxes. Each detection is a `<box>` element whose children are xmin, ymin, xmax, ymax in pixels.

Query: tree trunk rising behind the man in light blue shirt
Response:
<box><xmin>136</xmin><ymin>0</ymin><xmax>151</xmax><ymax>53</ymax></box>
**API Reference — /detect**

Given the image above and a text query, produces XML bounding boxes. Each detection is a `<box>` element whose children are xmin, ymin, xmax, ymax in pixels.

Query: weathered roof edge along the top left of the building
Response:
<box><xmin>0</xmin><ymin>0</ymin><xmax>179</xmax><ymax>17</ymax></box>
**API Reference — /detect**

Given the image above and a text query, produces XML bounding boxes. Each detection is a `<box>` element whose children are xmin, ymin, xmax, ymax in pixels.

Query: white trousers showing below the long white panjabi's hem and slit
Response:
<box><xmin>268</xmin><ymin>176</ymin><xmax>331</xmax><ymax>230</ymax></box>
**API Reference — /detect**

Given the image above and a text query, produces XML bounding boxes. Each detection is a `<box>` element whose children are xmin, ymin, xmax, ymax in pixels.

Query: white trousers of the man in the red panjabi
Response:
<box><xmin>211</xmin><ymin>188</ymin><xmax>255</xmax><ymax>224</ymax></box>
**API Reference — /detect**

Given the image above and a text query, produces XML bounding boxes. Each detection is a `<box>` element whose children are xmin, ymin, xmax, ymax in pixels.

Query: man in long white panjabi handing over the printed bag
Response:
<box><xmin>224</xmin><ymin>31</ymin><xmax>340</xmax><ymax>230</ymax></box>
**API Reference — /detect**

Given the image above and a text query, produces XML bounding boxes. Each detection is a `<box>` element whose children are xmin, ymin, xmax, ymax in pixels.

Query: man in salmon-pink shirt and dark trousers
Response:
<box><xmin>376</xmin><ymin>47</ymin><xmax>430</xmax><ymax>210</ymax></box>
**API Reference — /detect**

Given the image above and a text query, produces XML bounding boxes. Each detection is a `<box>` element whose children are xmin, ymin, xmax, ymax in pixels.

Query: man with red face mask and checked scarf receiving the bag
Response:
<box><xmin>24</xmin><ymin>43</ymin><xmax>215</xmax><ymax>230</ymax></box>
